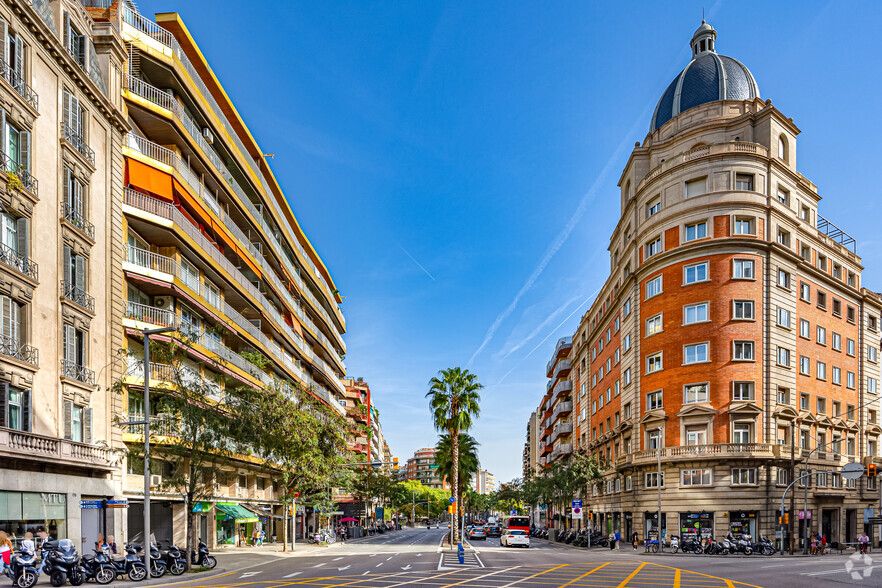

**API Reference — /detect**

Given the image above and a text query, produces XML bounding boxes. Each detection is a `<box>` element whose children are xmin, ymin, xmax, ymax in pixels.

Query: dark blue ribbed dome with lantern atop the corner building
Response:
<box><xmin>650</xmin><ymin>20</ymin><xmax>759</xmax><ymax>131</ymax></box>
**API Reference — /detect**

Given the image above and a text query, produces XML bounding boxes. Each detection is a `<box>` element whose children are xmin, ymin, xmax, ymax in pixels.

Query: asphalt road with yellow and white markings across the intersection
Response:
<box><xmin>106</xmin><ymin>528</ymin><xmax>882</xmax><ymax>588</ymax></box>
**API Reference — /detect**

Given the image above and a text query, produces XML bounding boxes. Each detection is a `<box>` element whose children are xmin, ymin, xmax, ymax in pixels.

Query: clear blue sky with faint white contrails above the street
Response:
<box><xmin>139</xmin><ymin>0</ymin><xmax>882</xmax><ymax>481</ymax></box>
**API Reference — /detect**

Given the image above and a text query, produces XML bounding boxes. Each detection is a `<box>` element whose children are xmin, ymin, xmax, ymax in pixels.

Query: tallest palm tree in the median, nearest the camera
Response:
<box><xmin>426</xmin><ymin>367</ymin><xmax>483</xmax><ymax>545</ymax></box>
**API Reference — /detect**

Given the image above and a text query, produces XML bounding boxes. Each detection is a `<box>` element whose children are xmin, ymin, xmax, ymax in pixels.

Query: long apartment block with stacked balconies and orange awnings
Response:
<box><xmin>70</xmin><ymin>0</ymin><xmax>346</xmax><ymax>546</ymax></box>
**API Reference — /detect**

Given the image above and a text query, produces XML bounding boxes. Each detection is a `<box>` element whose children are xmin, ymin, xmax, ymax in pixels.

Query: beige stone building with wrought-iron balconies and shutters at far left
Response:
<box><xmin>0</xmin><ymin>0</ymin><xmax>129</xmax><ymax>551</ymax></box>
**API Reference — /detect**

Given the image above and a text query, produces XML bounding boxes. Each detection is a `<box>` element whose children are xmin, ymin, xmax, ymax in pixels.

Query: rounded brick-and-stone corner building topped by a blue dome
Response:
<box><xmin>535</xmin><ymin>22</ymin><xmax>882</xmax><ymax>545</ymax></box>
